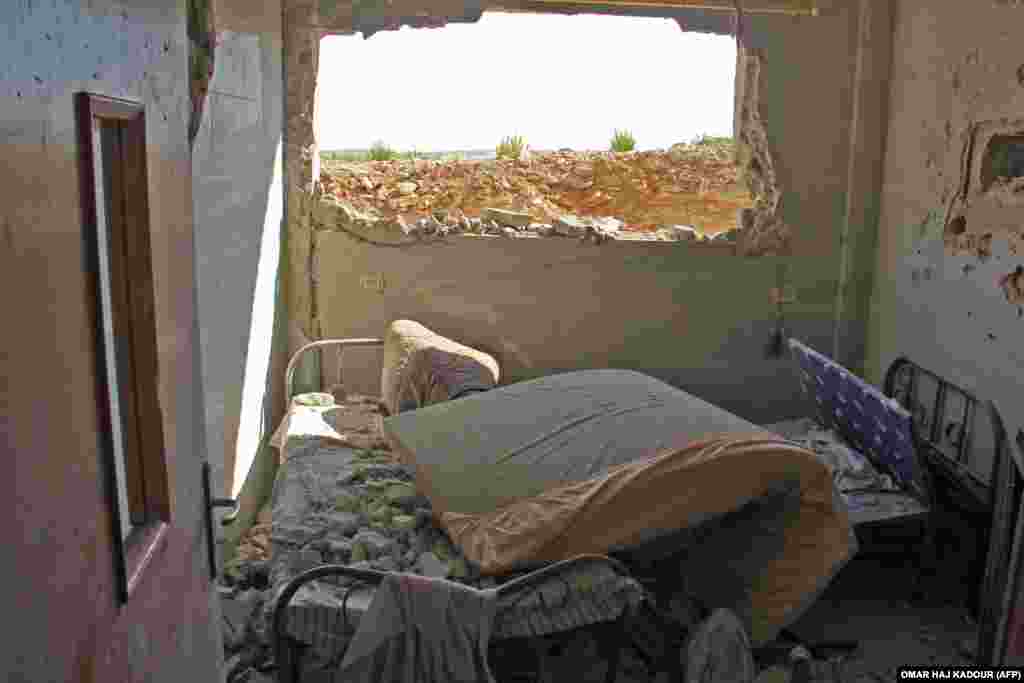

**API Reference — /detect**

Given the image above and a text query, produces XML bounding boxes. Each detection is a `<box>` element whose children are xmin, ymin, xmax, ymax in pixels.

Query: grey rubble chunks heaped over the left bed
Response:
<box><xmin>218</xmin><ymin>395</ymin><xmax>493</xmax><ymax>683</ymax></box>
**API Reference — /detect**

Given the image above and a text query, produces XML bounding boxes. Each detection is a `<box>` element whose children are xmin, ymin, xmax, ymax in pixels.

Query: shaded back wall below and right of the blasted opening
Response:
<box><xmin>289</xmin><ymin>3</ymin><xmax>872</xmax><ymax>428</ymax></box>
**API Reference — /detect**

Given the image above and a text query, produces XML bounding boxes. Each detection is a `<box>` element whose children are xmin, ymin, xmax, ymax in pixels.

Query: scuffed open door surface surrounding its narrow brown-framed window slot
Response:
<box><xmin>0</xmin><ymin>0</ymin><xmax>222</xmax><ymax>683</ymax></box>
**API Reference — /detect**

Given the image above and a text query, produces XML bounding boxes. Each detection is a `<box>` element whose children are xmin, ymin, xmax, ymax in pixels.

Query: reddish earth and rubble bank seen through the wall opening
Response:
<box><xmin>321</xmin><ymin>142</ymin><xmax>756</xmax><ymax>238</ymax></box>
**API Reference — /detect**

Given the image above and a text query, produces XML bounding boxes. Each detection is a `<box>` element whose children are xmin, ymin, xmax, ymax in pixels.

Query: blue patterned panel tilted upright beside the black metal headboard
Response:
<box><xmin>790</xmin><ymin>339</ymin><xmax>925</xmax><ymax>495</ymax></box>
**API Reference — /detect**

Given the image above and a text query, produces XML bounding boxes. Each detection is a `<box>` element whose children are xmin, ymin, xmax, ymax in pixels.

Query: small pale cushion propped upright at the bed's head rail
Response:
<box><xmin>381</xmin><ymin>321</ymin><xmax>499</xmax><ymax>415</ymax></box>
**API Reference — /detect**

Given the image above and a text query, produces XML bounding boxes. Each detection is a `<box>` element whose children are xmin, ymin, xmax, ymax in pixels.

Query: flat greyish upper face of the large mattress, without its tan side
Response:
<box><xmin>384</xmin><ymin>370</ymin><xmax>770</xmax><ymax>514</ymax></box>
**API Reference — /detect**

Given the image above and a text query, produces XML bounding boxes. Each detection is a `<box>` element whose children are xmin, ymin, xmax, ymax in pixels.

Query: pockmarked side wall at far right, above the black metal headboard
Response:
<box><xmin>868</xmin><ymin>0</ymin><xmax>1024</xmax><ymax>456</ymax></box>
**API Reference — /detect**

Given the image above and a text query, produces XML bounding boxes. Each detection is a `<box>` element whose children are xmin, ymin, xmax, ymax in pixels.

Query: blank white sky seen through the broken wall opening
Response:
<box><xmin>318</xmin><ymin>13</ymin><xmax>736</xmax><ymax>152</ymax></box>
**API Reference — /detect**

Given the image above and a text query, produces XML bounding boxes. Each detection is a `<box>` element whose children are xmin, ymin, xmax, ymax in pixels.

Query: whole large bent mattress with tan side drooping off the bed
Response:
<box><xmin>384</xmin><ymin>370</ymin><xmax>856</xmax><ymax>642</ymax></box>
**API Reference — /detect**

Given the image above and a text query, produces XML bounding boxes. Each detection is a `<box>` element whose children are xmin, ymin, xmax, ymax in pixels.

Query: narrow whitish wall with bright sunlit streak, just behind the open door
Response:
<box><xmin>193</xmin><ymin>0</ymin><xmax>284</xmax><ymax>496</ymax></box>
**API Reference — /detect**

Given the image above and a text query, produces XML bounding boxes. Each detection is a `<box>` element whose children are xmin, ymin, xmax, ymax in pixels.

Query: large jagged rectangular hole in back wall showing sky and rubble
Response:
<box><xmin>309</xmin><ymin>12</ymin><xmax>753</xmax><ymax>242</ymax></box>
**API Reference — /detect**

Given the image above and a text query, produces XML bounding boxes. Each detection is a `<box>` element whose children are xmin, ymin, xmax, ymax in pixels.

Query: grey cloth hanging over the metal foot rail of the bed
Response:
<box><xmin>335</xmin><ymin>573</ymin><xmax>498</xmax><ymax>683</ymax></box>
